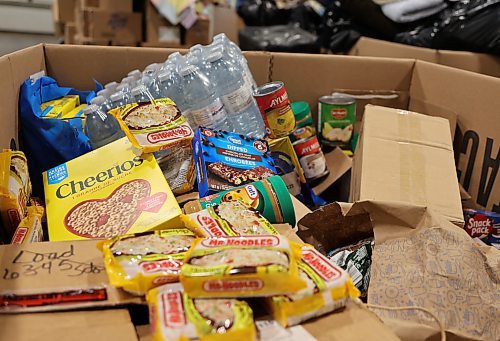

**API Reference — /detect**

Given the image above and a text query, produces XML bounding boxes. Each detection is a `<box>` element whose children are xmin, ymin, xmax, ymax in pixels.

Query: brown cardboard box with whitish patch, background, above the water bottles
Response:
<box><xmin>145</xmin><ymin>1</ymin><xmax>182</xmax><ymax>47</ymax></box>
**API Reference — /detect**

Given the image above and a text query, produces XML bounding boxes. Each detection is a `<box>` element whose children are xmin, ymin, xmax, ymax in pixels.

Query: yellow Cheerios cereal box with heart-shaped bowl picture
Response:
<box><xmin>43</xmin><ymin>138</ymin><xmax>181</xmax><ymax>241</ymax></box>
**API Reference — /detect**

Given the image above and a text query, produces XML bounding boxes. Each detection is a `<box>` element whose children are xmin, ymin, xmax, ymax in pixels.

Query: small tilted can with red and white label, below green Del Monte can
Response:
<box><xmin>293</xmin><ymin>136</ymin><xmax>330</xmax><ymax>182</ymax></box>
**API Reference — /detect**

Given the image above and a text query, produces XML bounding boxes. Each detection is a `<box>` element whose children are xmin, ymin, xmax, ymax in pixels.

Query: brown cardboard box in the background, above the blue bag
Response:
<box><xmin>76</xmin><ymin>8</ymin><xmax>142</xmax><ymax>42</ymax></box>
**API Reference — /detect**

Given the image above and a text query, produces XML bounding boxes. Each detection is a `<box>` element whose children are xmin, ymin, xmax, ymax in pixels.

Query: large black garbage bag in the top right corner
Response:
<box><xmin>395</xmin><ymin>0</ymin><xmax>500</xmax><ymax>54</ymax></box>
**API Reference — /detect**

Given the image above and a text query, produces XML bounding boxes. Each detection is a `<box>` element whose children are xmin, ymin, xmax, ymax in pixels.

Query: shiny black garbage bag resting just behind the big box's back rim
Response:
<box><xmin>239</xmin><ymin>25</ymin><xmax>319</xmax><ymax>53</ymax></box>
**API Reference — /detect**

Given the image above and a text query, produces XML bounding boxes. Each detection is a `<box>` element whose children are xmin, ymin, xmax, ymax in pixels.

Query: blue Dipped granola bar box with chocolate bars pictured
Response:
<box><xmin>193</xmin><ymin>128</ymin><xmax>276</xmax><ymax>198</ymax></box>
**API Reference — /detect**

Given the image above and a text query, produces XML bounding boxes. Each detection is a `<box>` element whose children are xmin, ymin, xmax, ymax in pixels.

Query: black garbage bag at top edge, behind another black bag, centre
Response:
<box><xmin>237</xmin><ymin>0</ymin><xmax>290</xmax><ymax>26</ymax></box>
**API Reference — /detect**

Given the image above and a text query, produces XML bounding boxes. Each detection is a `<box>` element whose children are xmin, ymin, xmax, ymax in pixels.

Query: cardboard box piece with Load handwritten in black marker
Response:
<box><xmin>0</xmin><ymin>240</ymin><xmax>143</xmax><ymax>312</ymax></box>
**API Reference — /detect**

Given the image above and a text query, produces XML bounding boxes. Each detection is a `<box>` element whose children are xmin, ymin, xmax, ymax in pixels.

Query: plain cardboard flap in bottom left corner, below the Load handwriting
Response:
<box><xmin>0</xmin><ymin>309</ymin><xmax>137</xmax><ymax>341</ymax></box>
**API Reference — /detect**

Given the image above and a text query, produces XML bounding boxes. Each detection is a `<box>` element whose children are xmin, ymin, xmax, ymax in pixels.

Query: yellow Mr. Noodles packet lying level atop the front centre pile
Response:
<box><xmin>180</xmin><ymin>235</ymin><xmax>305</xmax><ymax>298</ymax></box>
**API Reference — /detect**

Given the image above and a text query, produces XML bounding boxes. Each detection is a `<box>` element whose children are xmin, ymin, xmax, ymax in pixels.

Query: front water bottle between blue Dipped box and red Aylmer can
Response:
<box><xmin>207</xmin><ymin>49</ymin><xmax>265</xmax><ymax>138</ymax></box>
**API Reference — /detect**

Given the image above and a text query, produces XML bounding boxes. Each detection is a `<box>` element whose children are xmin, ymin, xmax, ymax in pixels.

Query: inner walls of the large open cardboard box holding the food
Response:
<box><xmin>0</xmin><ymin>45</ymin><xmax>500</xmax><ymax>210</ymax></box>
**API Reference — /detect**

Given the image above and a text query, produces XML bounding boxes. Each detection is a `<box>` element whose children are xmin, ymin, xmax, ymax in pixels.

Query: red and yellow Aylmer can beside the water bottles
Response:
<box><xmin>253</xmin><ymin>82</ymin><xmax>295</xmax><ymax>139</ymax></box>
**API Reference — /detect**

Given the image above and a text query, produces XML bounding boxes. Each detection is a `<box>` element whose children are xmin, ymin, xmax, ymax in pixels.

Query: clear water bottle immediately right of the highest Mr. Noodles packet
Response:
<box><xmin>180</xmin><ymin>64</ymin><xmax>231</xmax><ymax>130</ymax></box>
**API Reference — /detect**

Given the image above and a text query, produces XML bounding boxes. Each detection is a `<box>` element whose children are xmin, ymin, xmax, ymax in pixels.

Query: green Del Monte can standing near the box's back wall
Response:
<box><xmin>318</xmin><ymin>94</ymin><xmax>356</xmax><ymax>148</ymax></box>
